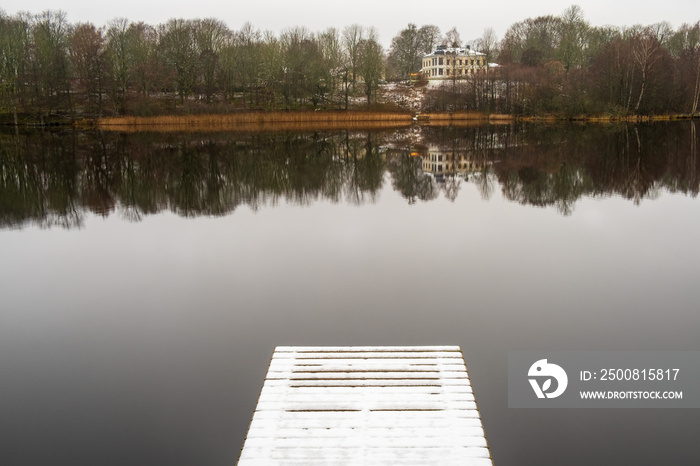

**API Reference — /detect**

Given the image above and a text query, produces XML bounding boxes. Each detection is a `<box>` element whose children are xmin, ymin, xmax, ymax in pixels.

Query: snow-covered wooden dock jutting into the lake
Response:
<box><xmin>238</xmin><ymin>346</ymin><xmax>493</xmax><ymax>466</ymax></box>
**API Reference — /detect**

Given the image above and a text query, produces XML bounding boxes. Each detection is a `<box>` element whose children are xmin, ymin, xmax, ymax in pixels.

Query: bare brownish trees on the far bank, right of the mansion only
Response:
<box><xmin>427</xmin><ymin>6</ymin><xmax>700</xmax><ymax>116</ymax></box>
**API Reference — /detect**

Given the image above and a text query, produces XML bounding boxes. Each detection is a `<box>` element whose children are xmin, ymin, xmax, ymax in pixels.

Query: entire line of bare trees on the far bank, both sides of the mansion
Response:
<box><xmin>0</xmin><ymin>6</ymin><xmax>700</xmax><ymax>124</ymax></box>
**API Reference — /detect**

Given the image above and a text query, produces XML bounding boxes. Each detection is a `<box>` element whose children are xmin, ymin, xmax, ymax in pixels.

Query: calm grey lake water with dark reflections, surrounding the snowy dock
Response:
<box><xmin>0</xmin><ymin>122</ymin><xmax>700</xmax><ymax>466</ymax></box>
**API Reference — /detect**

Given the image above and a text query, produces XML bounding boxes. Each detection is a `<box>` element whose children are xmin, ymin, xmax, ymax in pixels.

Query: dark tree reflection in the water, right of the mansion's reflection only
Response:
<box><xmin>427</xmin><ymin>122</ymin><xmax>698</xmax><ymax>215</ymax></box>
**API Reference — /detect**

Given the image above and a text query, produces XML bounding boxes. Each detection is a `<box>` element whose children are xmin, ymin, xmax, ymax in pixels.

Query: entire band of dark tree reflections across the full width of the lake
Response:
<box><xmin>0</xmin><ymin>122</ymin><xmax>700</xmax><ymax>227</ymax></box>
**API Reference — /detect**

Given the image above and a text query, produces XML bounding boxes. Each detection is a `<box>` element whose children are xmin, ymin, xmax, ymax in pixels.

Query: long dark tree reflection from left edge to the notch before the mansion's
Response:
<box><xmin>0</xmin><ymin>133</ymin><xmax>384</xmax><ymax>227</ymax></box>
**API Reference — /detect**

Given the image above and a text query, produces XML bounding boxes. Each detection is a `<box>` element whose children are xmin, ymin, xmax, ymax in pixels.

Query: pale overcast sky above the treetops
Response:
<box><xmin>5</xmin><ymin>0</ymin><xmax>700</xmax><ymax>45</ymax></box>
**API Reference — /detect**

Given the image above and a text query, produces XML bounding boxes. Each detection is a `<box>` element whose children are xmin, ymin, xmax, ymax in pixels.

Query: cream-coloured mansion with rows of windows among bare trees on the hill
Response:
<box><xmin>421</xmin><ymin>45</ymin><xmax>487</xmax><ymax>79</ymax></box>
